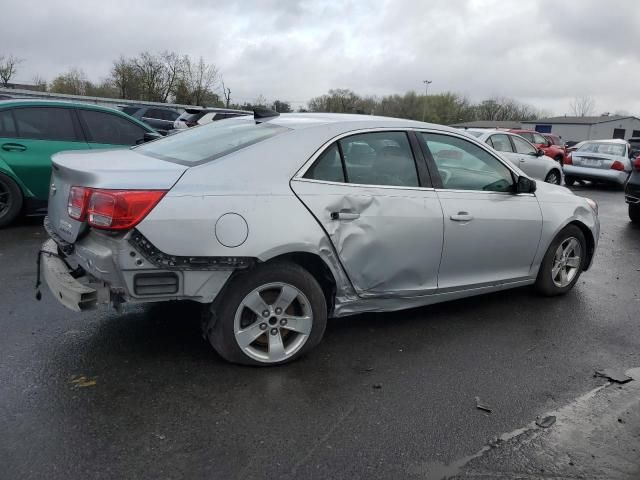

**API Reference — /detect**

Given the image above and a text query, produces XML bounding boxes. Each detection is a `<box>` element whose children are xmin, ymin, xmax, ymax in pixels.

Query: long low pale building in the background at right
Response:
<box><xmin>522</xmin><ymin>115</ymin><xmax>640</xmax><ymax>142</ymax></box>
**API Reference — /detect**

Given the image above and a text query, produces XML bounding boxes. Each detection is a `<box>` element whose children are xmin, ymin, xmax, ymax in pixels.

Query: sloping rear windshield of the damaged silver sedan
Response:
<box><xmin>135</xmin><ymin>118</ymin><xmax>291</xmax><ymax>166</ymax></box>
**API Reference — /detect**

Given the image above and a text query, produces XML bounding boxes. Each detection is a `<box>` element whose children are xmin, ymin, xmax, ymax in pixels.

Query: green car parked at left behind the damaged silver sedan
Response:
<box><xmin>0</xmin><ymin>100</ymin><xmax>159</xmax><ymax>228</ymax></box>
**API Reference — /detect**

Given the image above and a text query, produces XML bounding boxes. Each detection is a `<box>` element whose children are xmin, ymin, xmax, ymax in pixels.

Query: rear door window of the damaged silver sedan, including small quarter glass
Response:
<box><xmin>305</xmin><ymin>132</ymin><xmax>420</xmax><ymax>187</ymax></box>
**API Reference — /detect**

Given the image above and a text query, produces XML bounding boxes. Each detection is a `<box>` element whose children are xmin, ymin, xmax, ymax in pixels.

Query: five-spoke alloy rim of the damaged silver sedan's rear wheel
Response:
<box><xmin>234</xmin><ymin>282</ymin><xmax>313</xmax><ymax>363</ymax></box>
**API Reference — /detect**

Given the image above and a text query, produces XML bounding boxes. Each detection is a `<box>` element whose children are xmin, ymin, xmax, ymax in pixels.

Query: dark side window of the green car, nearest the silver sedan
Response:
<box><xmin>78</xmin><ymin>110</ymin><xmax>146</xmax><ymax>145</ymax></box>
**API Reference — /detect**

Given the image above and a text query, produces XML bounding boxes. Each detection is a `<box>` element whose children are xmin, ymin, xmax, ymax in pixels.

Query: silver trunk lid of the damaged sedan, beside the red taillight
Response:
<box><xmin>48</xmin><ymin>149</ymin><xmax>188</xmax><ymax>243</ymax></box>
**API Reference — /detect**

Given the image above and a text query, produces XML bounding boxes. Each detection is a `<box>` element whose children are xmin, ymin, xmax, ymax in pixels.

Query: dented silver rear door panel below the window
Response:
<box><xmin>291</xmin><ymin>179</ymin><xmax>443</xmax><ymax>296</ymax></box>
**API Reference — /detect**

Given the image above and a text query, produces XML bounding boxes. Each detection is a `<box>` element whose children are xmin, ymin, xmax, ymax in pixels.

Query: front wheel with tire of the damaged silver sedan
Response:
<box><xmin>535</xmin><ymin>225</ymin><xmax>587</xmax><ymax>297</ymax></box>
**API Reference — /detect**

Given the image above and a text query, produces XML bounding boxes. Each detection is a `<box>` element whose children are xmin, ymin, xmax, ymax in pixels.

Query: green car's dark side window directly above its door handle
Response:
<box><xmin>13</xmin><ymin>107</ymin><xmax>83</xmax><ymax>142</ymax></box>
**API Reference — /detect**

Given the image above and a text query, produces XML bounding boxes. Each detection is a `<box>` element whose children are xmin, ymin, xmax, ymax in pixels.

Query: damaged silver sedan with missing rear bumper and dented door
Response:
<box><xmin>40</xmin><ymin>111</ymin><xmax>599</xmax><ymax>365</ymax></box>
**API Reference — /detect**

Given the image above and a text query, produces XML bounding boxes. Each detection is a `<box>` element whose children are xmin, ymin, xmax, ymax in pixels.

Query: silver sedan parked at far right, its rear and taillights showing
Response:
<box><xmin>563</xmin><ymin>139</ymin><xmax>631</xmax><ymax>185</ymax></box>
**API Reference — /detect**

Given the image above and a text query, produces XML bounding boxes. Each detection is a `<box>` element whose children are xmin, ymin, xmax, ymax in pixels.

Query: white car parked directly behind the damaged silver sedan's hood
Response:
<box><xmin>465</xmin><ymin>128</ymin><xmax>562</xmax><ymax>185</ymax></box>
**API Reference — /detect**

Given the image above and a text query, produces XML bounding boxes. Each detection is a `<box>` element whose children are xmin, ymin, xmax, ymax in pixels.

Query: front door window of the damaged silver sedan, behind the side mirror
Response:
<box><xmin>421</xmin><ymin>133</ymin><xmax>514</xmax><ymax>192</ymax></box>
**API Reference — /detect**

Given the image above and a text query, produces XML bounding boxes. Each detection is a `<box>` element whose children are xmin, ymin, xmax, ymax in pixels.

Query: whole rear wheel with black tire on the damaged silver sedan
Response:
<box><xmin>206</xmin><ymin>262</ymin><xmax>327</xmax><ymax>366</ymax></box>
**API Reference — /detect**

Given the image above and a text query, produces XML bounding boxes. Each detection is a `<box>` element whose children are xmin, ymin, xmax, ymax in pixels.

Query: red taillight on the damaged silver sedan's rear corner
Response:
<box><xmin>68</xmin><ymin>187</ymin><xmax>167</xmax><ymax>230</ymax></box>
